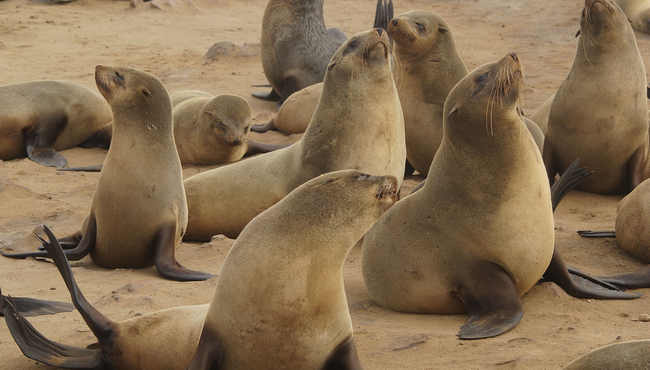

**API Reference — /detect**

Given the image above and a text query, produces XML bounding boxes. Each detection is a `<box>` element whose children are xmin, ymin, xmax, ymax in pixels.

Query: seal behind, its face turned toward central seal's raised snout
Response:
<box><xmin>388</xmin><ymin>10</ymin><xmax>467</xmax><ymax>176</ymax></box>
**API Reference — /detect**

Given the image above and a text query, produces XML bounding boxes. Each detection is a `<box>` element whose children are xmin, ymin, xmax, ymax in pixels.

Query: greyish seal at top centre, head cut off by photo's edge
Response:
<box><xmin>253</xmin><ymin>0</ymin><xmax>393</xmax><ymax>106</ymax></box>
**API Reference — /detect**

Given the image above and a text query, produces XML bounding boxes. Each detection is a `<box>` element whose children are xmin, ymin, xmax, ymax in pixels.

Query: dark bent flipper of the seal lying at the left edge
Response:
<box><xmin>25</xmin><ymin>113</ymin><xmax>68</xmax><ymax>167</ymax></box>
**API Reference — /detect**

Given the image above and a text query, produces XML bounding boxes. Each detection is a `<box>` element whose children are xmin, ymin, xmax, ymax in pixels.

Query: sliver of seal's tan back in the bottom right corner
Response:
<box><xmin>563</xmin><ymin>340</ymin><xmax>650</xmax><ymax>370</ymax></box>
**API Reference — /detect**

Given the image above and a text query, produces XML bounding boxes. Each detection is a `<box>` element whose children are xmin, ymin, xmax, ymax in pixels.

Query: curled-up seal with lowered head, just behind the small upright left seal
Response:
<box><xmin>169</xmin><ymin>90</ymin><xmax>253</xmax><ymax>165</ymax></box>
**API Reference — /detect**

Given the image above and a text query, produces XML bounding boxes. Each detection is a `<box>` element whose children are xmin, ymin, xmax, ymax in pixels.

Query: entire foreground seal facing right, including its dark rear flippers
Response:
<box><xmin>6</xmin><ymin>170</ymin><xmax>397</xmax><ymax>370</ymax></box>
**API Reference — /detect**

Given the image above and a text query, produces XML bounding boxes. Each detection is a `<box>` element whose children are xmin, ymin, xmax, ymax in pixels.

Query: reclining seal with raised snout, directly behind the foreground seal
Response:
<box><xmin>184</xmin><ymin>29</ymin><xmax>406</xmax><ymax>240</ymax></box>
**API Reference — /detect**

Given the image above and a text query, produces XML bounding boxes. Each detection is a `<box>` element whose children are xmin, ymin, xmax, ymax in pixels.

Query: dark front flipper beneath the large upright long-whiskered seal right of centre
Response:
<box><xmin>458</xmin><ymin>260</ymin><xmax>524</xmax><ymax>339</ymax></box>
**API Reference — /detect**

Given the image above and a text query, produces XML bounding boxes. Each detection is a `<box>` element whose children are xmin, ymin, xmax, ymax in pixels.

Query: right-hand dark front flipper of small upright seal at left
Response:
<box><xmin>155</xmin><ymin>223</ymin><xmax>214</xmax><ymax>281</ymax></box>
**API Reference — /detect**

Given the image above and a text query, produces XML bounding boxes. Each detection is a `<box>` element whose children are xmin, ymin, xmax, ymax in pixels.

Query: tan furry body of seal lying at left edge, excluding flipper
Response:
<box><xmin>0</xmin><ymin>80</ymin><xmax>112</xmax><ymax>161</ymax></box>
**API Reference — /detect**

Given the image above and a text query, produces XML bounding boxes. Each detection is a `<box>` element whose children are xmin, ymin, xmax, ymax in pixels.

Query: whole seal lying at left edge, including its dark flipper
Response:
<box><xmin>0</xmin><ymin>81</ymin><xmax>112</xmax><ymax>167</ymax></box>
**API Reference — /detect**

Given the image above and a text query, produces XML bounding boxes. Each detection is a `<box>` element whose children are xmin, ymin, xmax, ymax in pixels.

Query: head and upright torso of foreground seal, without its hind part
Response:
<box><xmin>188</xmin><ymin>170</ymin><xmax>397</xmax><ymax>370</ymax></box>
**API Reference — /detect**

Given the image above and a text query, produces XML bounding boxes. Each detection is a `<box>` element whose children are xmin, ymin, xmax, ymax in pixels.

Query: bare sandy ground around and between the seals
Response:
<box><xmin>0</xmin><ymin>0</ymin><xmax>650</xmax><ymax>370</ymax></box>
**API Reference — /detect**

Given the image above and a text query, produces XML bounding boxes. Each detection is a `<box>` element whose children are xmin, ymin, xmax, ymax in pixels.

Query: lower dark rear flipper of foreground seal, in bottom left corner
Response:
<box><xmin>4</xmin><ymin>297</ymin><xmax>105</xmax><ymax>369</ymax></box>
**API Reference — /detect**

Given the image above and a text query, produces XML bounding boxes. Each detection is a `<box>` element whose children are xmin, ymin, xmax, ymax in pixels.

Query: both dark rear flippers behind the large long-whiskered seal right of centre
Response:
<box><xmin>543</xmin><ymin>158</ymin><xmax>641</xmax><ymax>299</ymax></box>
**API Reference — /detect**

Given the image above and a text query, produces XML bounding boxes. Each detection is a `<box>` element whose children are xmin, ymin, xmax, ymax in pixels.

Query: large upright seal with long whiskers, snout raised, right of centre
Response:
<box><xmin>362</xmin><ymin>54</ymin><xmax>554</xmax><ymax>339</ymax></box>
